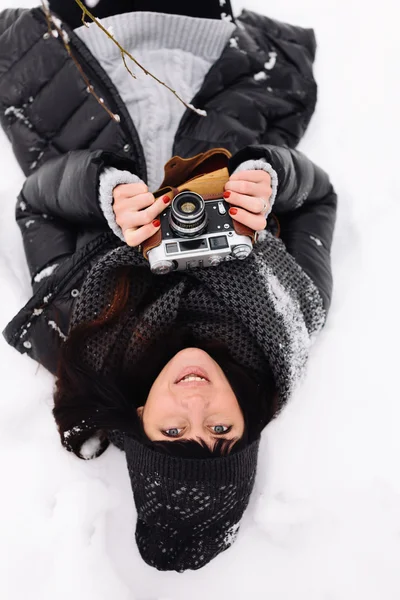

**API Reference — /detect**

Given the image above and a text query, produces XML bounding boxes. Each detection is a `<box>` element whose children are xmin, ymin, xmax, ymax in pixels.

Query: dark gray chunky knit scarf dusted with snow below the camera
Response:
<box><xmin>71</xmin><ymin>233</ymin><xmax>325</xmax><ymax>407</ymax></box>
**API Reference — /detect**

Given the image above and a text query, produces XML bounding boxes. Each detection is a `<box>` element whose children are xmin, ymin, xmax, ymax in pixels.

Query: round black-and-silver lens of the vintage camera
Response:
<box><xmin>169</xmin><ymin>192</ymin><xmax>207</xmax><ymax>237</ymax></box>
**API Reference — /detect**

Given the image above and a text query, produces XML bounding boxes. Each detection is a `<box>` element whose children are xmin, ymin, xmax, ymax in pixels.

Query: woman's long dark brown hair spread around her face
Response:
<box><xmin>53</xmin><ymin>268</ymin><xmax>276</xmax><ymax>458</ymax></box>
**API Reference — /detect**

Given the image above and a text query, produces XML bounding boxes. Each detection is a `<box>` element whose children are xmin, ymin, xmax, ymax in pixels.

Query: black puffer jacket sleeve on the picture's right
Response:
<box><xmin>229</xmin><ymin>145</ymin><xmax>337</xmax><ymax>311</ymax></box>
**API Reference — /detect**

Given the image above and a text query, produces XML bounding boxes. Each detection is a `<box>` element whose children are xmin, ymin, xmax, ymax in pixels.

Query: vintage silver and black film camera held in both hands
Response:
<box><xmin>147</xmin><ymin>190</ymin><xmax>253</xmax><ymax>275</ymax></box>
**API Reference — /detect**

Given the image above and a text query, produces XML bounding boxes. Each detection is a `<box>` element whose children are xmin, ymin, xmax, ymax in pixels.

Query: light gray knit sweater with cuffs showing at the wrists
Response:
<box><xmin>75</xmin><ymin>12</ymin><xmax>277</xmax><ymax>239</ymax></box>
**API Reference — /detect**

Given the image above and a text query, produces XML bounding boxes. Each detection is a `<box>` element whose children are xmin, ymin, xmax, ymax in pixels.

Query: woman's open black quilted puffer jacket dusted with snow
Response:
<box><xmin>0</xmin><ymin>4</ymin><xmax>336</xmax><ymax>372</ymax></box>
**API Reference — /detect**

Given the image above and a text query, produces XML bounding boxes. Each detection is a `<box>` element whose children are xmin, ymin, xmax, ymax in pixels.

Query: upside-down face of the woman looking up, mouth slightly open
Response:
<box><xmin>138</xmin><ymin>348</ymin><xmax>244</xmax><ymax>447</ymax></box>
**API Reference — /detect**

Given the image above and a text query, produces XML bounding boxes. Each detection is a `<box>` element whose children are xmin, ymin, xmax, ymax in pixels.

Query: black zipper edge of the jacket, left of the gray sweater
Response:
<box><xmin>31</xmin><ymin>7</ymin><xmax>147</xmax><ymax>183</ymax></box>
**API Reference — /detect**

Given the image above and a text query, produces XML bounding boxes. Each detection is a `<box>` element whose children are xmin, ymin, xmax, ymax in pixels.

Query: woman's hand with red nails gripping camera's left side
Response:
<box><xmin>113</xmin><ymin>183</ymin><xmax>170</xmax><ymax>246</ymax></box>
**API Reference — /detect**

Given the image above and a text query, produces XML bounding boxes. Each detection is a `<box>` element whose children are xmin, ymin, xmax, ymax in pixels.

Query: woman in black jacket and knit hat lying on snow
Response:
<box><xmin>0</xmin><ymin>0</ymin><xmax>336</xmax><ymax>571</ymax></box>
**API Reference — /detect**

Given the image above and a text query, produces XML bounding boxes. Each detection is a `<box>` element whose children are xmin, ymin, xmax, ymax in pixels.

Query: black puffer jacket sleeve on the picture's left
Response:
<box><xmin>16</xmin><ymin>150</ymin><xmax>139</xmax><ymax>281</ymax></box>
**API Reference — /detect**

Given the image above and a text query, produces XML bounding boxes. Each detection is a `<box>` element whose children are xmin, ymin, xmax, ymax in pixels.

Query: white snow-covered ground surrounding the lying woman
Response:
<box><xmin>0</xmin><ymin>0</ymin><xmax>400</xmax><ymax>600</ymax></box>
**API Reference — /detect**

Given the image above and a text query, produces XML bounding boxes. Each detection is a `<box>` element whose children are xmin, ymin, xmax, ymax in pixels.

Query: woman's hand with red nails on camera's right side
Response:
<box><xmin>224</xmin><ymin>169</ymin><xmax>272</xmax><ymax>231</ymax></box>
